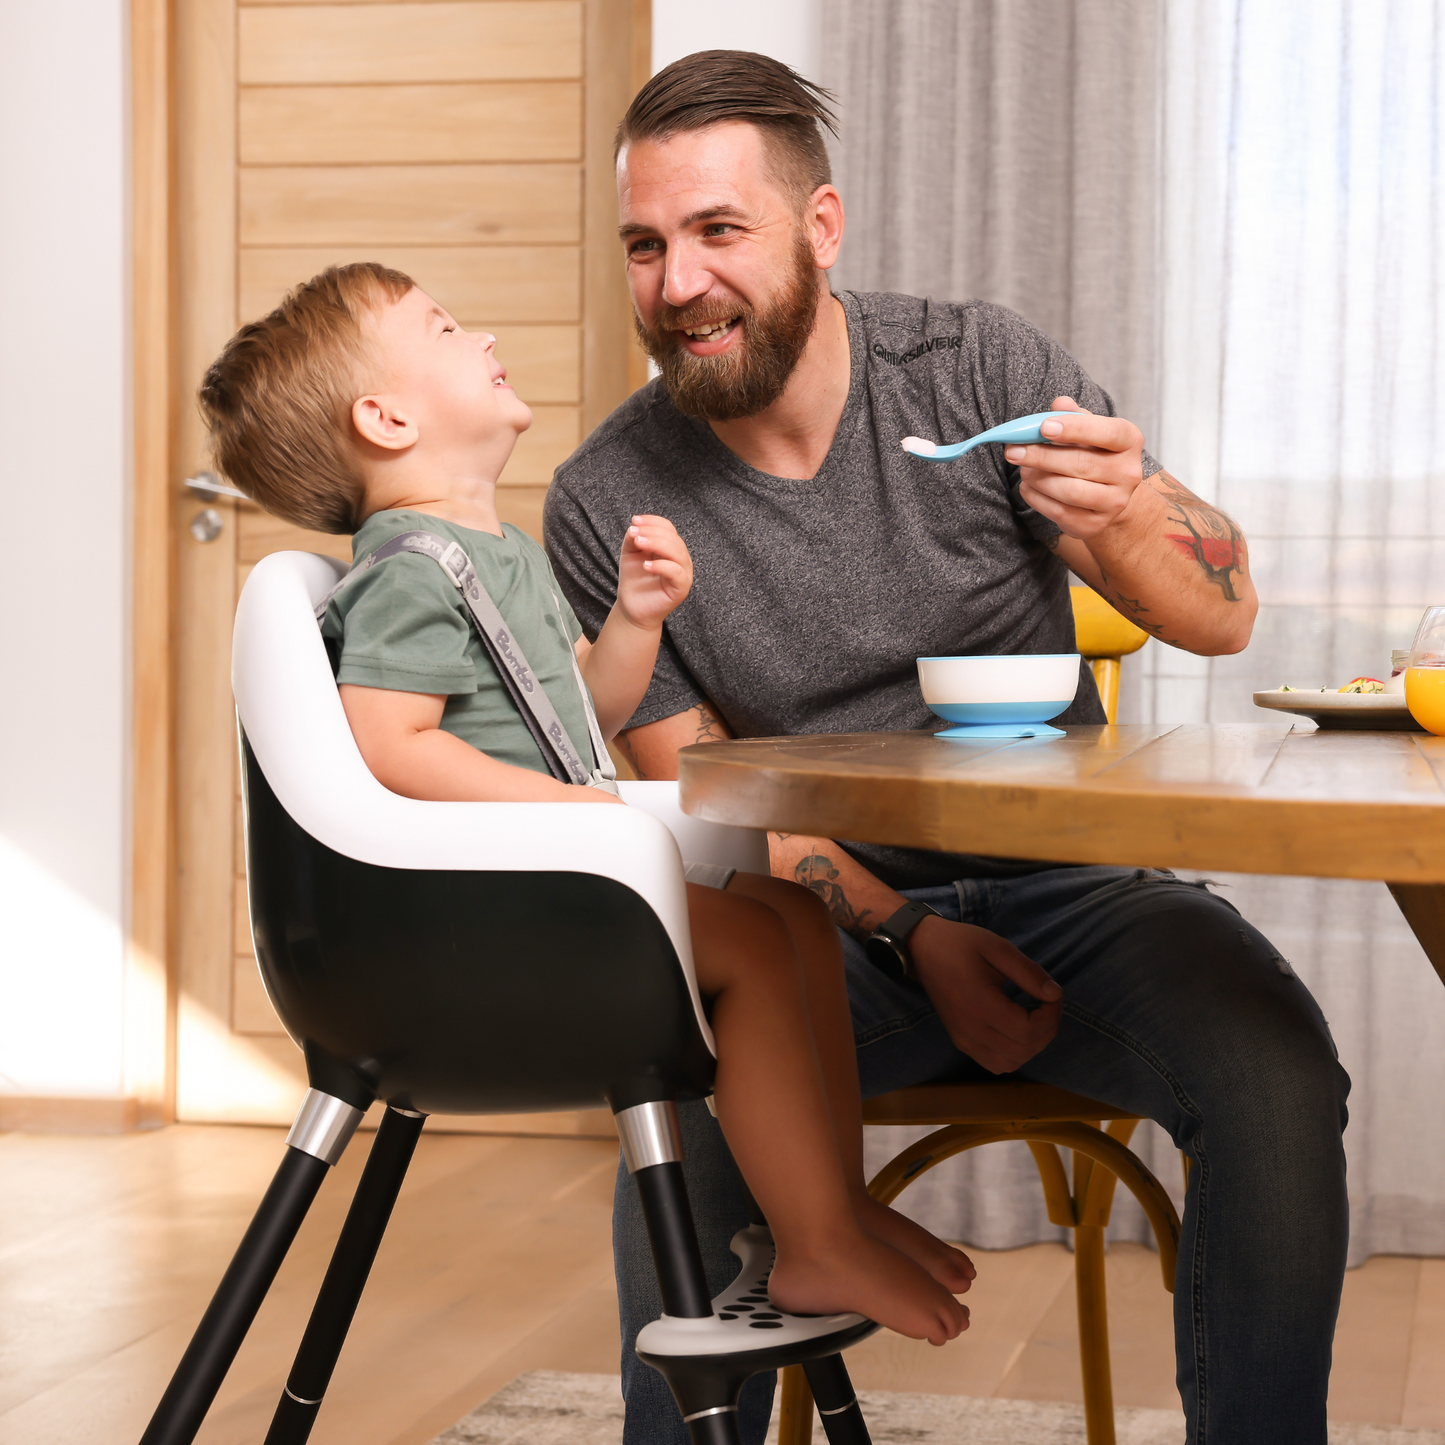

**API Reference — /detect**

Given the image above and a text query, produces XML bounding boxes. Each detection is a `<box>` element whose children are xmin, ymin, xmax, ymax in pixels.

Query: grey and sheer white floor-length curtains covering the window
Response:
<box><xmin>821</xmin><ymin>0</ymin><xmax>1445</xmax><ymax>1263</ymax></box>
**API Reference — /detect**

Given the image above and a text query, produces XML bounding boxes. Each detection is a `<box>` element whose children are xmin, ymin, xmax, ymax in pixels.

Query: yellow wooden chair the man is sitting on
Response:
<box><xmin>777</xmin><ymin>587</ymin><xmax>1161</xmax><ymax>1445</ymax></box>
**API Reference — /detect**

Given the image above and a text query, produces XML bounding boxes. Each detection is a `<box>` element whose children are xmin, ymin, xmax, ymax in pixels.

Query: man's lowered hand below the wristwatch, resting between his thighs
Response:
<box><xmin>909</xmin><ymin>918</ymin><xmax>1064</xmax><ymax>1074</ymax></box>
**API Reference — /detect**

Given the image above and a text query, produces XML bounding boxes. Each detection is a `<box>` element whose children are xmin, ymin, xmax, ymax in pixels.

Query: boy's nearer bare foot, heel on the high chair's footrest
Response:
<box><xmin>767</xmin><ymin>1231</ymin><xmax>968</xmax><ymax>1345</ymax></box>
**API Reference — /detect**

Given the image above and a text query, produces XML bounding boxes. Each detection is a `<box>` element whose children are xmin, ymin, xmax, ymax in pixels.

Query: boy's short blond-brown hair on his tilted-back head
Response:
<box><xmin>199</xmin><ymin>262</ymin><xmax>415</xmax><ymax>532</ymax></box>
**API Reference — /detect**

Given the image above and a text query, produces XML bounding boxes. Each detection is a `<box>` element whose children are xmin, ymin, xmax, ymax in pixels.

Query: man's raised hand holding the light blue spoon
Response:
<box><xmin>1003</xmin><ymin>396</ymin><xmax>1144</xmax><ymax>542</ymax></box>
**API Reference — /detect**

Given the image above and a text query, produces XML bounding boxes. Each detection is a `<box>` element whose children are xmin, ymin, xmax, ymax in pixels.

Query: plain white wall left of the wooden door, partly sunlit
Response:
<box><xmin>0</xmin><ymin>0</ymin><xmax>129</xmax><ymax>1095</ymax></box>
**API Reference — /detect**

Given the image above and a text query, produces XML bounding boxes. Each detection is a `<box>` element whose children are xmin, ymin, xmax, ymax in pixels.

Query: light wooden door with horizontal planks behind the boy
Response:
<box><xmin>171</xmin><ymin>0</ymin><xmax>647</xmax><ymax>1131</ymax></box>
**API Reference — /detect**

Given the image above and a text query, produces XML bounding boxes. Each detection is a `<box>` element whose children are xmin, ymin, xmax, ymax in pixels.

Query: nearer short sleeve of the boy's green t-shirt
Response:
<box><xmin>322</xmin><ymin>552</ymin><xmax>477</xmax><ymax>696</ymax></box>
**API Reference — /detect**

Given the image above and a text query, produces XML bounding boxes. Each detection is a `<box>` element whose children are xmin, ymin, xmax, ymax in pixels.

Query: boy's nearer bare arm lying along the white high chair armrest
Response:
<box><xmin>341</xmin><ymin>682</ymin><xmax>620</xmax><ymax>803</ymax></box>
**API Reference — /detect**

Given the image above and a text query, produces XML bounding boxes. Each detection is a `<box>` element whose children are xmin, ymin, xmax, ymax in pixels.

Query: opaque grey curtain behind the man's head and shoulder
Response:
<box><xmin>822</xmin><ymin>0</ymin><xmax>1160</xmax><ymax>435</ymax></box>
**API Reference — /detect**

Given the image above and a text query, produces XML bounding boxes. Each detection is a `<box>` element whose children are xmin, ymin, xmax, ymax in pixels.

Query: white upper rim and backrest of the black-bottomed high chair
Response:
<box><xmin>231</xmin><ymin>552</ymin><xmax>722</xmax><ymax>1046</ymax></box>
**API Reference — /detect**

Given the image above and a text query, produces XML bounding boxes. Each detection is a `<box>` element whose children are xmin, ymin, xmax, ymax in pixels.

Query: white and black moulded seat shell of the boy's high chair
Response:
<box><xmin>231</xmin><ymin>552</ymin><xmax>722</xmax><ymax>1113</ymax></box>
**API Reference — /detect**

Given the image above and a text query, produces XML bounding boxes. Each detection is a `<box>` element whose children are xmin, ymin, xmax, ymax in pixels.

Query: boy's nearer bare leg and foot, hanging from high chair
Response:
<box><xmin>688</xmin><ymin>884</ymin><xmax>967</xmax><ymax>1344</ymax></box>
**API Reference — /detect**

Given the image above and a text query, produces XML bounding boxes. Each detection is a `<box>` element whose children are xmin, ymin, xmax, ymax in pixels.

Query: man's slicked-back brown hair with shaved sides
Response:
<box><xmin>613</xmin><ymin>51</ymin><xmax>838</xmax><ymax>207</ymax></box>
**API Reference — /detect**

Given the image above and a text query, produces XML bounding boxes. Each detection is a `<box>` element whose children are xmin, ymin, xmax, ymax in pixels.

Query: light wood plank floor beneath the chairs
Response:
<box><xmin>0</xmin><ymin>1126</ymin><xmax>1445</xmax><ymax>1445</ymax></box>
